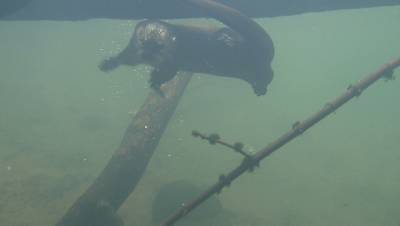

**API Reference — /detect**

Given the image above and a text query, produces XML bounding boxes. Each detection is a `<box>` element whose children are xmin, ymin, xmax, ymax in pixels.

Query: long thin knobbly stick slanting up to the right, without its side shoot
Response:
<box><xmin>161</xmin><ymin>58</ymin><xmax>400</xmax><ymax>226</ymax></box>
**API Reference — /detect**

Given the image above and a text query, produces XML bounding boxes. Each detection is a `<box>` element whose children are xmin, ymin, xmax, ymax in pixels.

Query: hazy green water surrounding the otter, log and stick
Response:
<box><xmin>0</xmin><ymin>7</ymin><xmax>400</xmax><ymax>226</ymax></box>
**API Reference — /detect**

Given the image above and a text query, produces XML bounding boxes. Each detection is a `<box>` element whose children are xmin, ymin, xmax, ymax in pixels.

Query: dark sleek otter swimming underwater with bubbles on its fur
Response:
<box><xmin>99</xmin><ymin>0</ymin><xmax>274</xmax><ymax>96</ymax></box>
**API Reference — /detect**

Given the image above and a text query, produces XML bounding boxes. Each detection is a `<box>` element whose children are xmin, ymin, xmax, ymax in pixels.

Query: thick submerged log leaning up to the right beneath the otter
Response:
<box><xmin>56</xmin><ymin>73</ymin><xmax>192</xmax><ymax>226</ymax></box>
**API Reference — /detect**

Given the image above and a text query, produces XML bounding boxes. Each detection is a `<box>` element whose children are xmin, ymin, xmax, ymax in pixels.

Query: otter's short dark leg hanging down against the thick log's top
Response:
<box><xmin>149</xmin><ymin>64</ymin><xmax>178</xmax><ymax>96</ymax></box>
